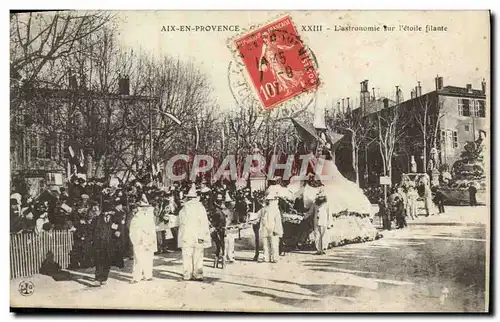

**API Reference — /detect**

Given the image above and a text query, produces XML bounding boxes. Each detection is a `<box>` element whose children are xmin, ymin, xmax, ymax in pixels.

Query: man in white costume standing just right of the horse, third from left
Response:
<box><xmin>259</xmin><ymin>191</ymin><xmax>283</xmax><ymax>263</ymax></box>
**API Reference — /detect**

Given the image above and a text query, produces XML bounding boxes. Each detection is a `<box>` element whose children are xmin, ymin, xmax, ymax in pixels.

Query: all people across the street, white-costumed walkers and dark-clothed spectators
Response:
<box><xmin>11</xmin><ymin>167</ymin><xmax>472</xmax><ymax>285</ymax></box>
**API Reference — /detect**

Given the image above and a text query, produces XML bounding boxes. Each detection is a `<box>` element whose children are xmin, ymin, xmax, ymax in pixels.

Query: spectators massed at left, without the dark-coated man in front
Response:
<box><xmin>10</xmin><ymin>171</ymin><xmax>274</xmax><ymax>267</ymax></box>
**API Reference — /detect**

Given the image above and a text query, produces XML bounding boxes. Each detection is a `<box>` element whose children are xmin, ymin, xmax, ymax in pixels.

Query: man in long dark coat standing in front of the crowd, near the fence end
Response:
<box><xmin>92</xmin><ymin>202</ymin><xmax>123</xmax><ymax>285</ymax></box>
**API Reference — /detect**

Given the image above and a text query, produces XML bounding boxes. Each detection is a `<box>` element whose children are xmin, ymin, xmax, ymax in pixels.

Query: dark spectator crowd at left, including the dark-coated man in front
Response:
<box><xmin>10</xmin><ymin>171</ymin><xmax>292</xmax><ymax>282</ymax></box>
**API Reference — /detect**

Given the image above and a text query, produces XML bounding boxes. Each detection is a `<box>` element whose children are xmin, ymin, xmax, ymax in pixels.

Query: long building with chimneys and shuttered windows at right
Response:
<box><xmin>348</xmin><ymin>76</ymin><xmax>489</xmax><ymax>186</ymax></box>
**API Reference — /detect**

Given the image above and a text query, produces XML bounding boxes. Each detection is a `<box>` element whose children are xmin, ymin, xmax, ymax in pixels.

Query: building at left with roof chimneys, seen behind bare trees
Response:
<box><xmin>10</xmin><ymin>78</ymin><xmax>156</xmax><ymax>195</ymax></box>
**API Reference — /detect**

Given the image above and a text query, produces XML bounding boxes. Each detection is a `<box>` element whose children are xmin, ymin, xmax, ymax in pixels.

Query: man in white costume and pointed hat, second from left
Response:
<box><xmin>178</xmin><ymin>185</ymin><xmax>212</xmax><ymax>281</ymax></box>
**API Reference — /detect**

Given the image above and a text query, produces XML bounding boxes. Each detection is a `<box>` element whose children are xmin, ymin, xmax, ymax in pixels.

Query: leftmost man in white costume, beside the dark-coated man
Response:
<box><xmin>130</xmin><ymin>200</ymin><xmax>157</xmax><ymax>284</ymax></box>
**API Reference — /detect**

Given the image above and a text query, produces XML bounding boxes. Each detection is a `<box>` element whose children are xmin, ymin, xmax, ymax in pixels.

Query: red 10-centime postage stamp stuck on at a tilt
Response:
<box><xmin>234</xmin><ymin>15</ymin><xmax>320</xmax><ymax>110</ymax></box>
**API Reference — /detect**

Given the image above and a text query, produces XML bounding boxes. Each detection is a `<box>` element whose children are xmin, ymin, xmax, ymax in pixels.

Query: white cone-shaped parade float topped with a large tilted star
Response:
<box><xmin>274</xmin><ymin>120</ymin><xmax>382</xmax><ymax>248</ymax></box>
